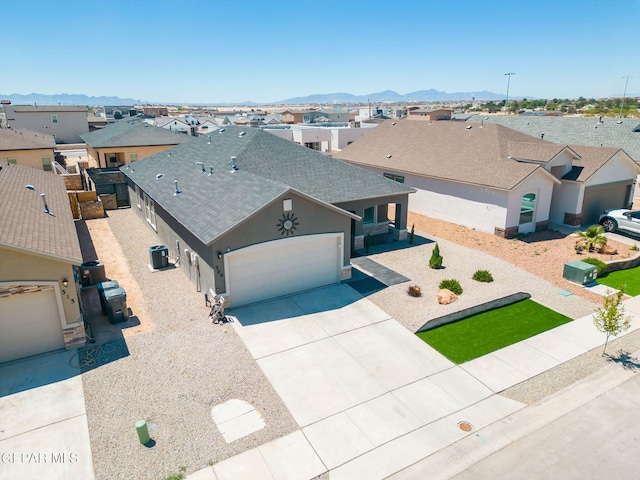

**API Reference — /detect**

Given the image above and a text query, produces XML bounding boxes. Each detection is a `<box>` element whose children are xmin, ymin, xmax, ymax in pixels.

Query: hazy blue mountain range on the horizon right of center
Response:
<box><xmin>274</xmin><ymin>89</ymin><xmax>505</xmax><ymax>104</ymax></box>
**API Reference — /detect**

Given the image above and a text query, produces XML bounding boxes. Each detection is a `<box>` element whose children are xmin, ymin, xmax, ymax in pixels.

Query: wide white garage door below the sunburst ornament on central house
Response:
<box><xmin>225</xmin><ymin>233</ymin><xmax>343</xmax><ymax>307</ymax></box>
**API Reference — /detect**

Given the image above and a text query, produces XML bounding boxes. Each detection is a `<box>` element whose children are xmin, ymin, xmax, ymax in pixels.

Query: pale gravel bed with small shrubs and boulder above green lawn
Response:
<box><xmin>360</xmin><ymin>232</ymin><xmax>600</xmax><ymax>332</ymax></box>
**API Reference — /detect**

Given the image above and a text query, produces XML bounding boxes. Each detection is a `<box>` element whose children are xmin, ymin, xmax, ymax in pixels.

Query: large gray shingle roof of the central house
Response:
<box><xmin>121</xmin><ymin>127</ymin><xmax>414</xmax><ymax>244</ymax></box>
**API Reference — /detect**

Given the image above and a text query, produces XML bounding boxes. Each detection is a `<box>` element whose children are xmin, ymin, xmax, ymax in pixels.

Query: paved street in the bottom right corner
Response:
<box><xmin>453</xmin><ymin>375</ymin><xmax>640</xmax><ymax>480</ymax></box>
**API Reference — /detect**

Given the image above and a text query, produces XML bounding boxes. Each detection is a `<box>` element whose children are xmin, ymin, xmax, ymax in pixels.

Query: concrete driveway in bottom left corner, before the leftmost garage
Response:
<box><xmin>0</xmin><ymin>351</ymin><xmax>94</xmax><ymax>480</ymax></box>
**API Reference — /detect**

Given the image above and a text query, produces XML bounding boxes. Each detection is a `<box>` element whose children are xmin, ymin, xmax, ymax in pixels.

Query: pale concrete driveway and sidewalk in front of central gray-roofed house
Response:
<box><xmin>188</xmin><ymin>285</ymin><xmax>640</xmax><ymax>480</ymax></box>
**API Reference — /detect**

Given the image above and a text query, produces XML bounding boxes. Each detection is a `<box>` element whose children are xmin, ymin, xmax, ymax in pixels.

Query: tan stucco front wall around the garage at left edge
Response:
<box><xmin>0</xmin><ymin>248</ymin><xmax>80</xmax><ymax>327</ymax></box>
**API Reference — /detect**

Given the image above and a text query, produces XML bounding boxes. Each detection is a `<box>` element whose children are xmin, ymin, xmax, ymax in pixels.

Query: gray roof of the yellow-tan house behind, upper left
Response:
<box><xmin>80</xmin><ymin>121</ymin><xmax>193</xmax><ymax>148</ymax></box>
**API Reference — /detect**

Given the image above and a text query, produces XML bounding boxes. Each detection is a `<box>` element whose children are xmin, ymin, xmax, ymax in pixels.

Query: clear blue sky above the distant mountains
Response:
<box><xmin>5</xmin><ymin>0</ymin><xmax>640</xmax><ymax>103</ymax></box>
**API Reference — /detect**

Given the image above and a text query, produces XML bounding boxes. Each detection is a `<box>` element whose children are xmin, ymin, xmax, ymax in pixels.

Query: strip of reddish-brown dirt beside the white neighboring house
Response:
<box><xmin>407</xmin><ymin>212</ymin><xmax>640</xmax><ymax>303</ymax></box>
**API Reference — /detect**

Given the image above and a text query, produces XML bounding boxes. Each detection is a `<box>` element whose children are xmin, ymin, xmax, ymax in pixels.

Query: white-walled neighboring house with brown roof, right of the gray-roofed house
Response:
<box><xmin>336</xmin><ymin>119</ymin><xmax>639</xmax><ymax>237</ymax></box>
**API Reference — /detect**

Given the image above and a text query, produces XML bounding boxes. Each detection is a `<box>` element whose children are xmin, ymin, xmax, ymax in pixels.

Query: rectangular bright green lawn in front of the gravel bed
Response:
<box><xmin>417</xmin><ymin>300</ymin><xmax>571</xmax><ymax>363</ymax></box>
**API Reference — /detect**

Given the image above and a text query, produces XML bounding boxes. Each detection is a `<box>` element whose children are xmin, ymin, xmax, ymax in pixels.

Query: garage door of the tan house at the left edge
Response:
<box><xmin>0</xmin><ymin>288</ymin><xmax>64</xmax><ymax>363</ymax></box>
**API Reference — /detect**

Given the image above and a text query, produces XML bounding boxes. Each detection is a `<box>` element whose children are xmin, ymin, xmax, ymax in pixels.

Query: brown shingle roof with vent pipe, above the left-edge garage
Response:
<box><xmin>0</xmin><ymin>165</ymin><xmax>82</xmax><ymax>265</ymax></box>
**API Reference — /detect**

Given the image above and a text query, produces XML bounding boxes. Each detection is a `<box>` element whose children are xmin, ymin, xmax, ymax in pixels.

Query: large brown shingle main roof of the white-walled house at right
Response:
<box><xmin>336</xmin><ymin>119</ymin><xmax>564</xmax><ymax>190</ymax></box>
